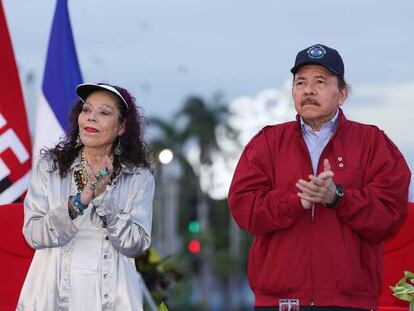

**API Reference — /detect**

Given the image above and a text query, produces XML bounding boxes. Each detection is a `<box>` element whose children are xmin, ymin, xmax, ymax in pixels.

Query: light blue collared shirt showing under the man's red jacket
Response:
<box><xmin>300</xmin><ymin>110</ymin><xmax>339</xmax><ymax>176</ymax></box>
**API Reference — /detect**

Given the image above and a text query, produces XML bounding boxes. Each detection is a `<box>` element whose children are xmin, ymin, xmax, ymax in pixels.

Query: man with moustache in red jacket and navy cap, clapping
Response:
<box><xmin>228</xmin><ymin>44</ymin><xmax>411</xmax><ymax>310</ymax></box>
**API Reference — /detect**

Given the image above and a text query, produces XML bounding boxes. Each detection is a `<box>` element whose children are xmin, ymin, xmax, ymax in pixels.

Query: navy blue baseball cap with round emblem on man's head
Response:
<box><xmin>290</xmin><ymin>44</ymin><xmax>345</xmax><ymax>76</ymax></box>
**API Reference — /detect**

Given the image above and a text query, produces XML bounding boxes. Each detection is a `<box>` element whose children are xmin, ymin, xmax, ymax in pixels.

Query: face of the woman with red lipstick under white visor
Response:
<box><xmin>78</xmin><ymin>91</ymin><xmax>125</xmax><ymax>151</ymax></box>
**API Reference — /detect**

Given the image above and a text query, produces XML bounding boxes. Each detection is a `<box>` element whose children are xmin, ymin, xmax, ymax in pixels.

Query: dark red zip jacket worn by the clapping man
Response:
<box><xmin>228</xmin><ymin>111</ymin><xmax>411</xmax><ymax>309</ymax></box>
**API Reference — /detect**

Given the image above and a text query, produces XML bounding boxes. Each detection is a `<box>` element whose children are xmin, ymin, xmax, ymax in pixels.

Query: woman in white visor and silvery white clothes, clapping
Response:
<box><xmin>17</xmin><ymin>84</ymin><xmax>154</xmax><ymax>311</ymax></box>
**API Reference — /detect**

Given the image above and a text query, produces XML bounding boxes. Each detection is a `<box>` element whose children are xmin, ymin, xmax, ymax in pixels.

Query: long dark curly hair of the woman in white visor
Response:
<box><xmin>41</xmin><ymin>86</ymin><xmax>151</xmax><ymax>176</ymax></box>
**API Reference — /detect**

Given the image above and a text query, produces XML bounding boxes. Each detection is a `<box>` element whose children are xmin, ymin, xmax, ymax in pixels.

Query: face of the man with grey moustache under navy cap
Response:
<box><xmin>292</xmin><ymin>65</ymin><xmax>348</xmax><ymax>130</ymax></box>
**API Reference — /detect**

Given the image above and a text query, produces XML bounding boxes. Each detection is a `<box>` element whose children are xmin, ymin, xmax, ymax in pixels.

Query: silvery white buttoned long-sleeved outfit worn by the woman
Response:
<box><xmin>17</xmin><ymin>157</ymin><xmax>154</xmax><ymax>311</ymax></box>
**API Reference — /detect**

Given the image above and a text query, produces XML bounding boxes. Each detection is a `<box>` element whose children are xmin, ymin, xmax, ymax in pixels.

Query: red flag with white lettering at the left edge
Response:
<box><xmin>0</xmin><ymin>1</ymin><xmax>32</xmax><ymax>204</ymax></box>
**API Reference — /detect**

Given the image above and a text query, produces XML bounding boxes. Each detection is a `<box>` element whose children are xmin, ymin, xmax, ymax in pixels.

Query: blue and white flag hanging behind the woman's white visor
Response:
<box><xmin>33</xmin><ymin>0</ymin><xmax>82</xmax><ymax>158</ymax></box>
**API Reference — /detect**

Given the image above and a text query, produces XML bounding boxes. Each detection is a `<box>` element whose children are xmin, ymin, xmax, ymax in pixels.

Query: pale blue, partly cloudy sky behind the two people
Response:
<box><xmin>3</xmin><ymin>0</ymin><xmax>414</xmax><ymax>199</ymax></box>
